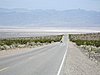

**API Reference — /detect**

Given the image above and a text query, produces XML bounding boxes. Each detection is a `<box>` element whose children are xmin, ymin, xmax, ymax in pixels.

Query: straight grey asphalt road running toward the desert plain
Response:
<box><xmin>0</xmin><ymin>36</ymin><xmax>67</xmax><ymax>75</ymax></box>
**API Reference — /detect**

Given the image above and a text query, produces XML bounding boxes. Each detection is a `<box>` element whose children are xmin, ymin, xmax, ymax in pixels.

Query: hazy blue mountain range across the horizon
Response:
<box><xmin>0</xmin><ymin>8</ymin><xmax>100</xmax><ymax>27</ymax></box>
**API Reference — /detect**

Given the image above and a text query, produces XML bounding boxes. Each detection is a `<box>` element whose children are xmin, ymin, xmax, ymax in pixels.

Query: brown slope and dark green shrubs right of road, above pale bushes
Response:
<box><xmin>69</xmin><ymin>33</ymin><xmax>100</xmax><ymax>47</ymax></box>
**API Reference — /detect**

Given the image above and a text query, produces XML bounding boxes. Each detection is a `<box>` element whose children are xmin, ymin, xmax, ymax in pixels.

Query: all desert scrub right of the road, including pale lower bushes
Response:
<box><xmin>69</xmin><ymin>33</ymin><xmax>100</xmax><ymax>61</ymax></box>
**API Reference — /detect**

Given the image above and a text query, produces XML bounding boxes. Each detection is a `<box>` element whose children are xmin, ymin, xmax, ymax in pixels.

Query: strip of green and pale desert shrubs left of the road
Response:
<box><xmin>0</xmin><ymin>35</ymin><xmax>62</xmax><ymax>50</ymax></box>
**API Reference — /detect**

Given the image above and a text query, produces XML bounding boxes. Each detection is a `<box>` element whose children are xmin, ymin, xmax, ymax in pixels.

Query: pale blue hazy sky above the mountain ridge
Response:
<box><xmin>0</xmin><ymin>0</ymin><xmax>100</xmax><ymax>11</ymax></box>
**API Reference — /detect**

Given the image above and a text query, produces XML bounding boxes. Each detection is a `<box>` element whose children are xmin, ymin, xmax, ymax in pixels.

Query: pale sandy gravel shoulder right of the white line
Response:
<box><xmin>63</xmin><ymin>42</ymin><xmax>100</xmax><ymax>75</ymax></box>
